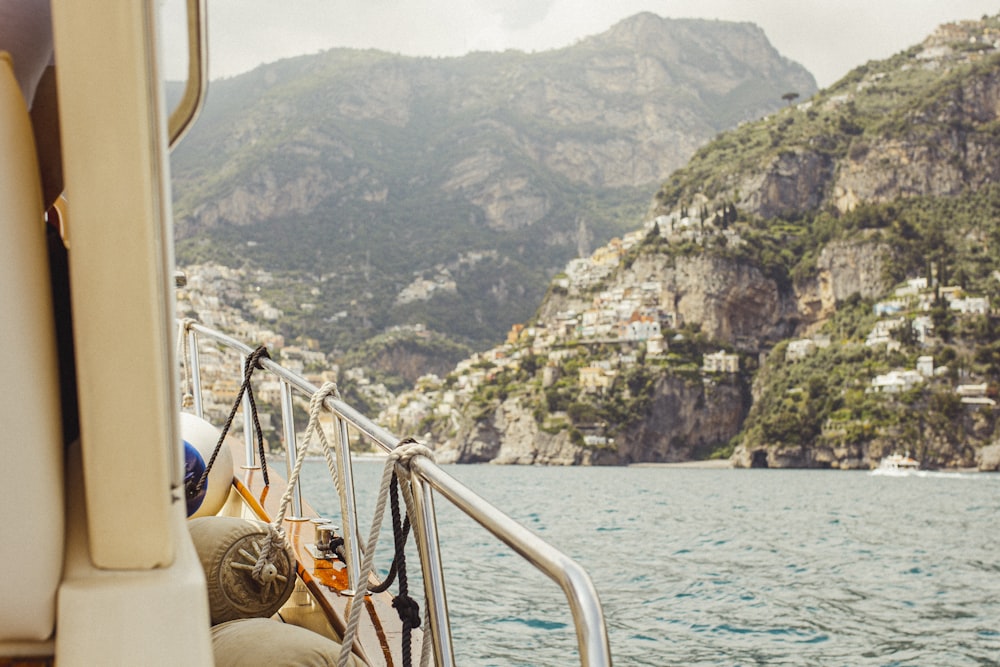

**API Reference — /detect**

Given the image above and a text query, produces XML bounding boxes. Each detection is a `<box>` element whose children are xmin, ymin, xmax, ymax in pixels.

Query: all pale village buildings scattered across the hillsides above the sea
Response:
<box><xmin>177</xmin><ymin>206</ymin><xmax>995</xmax><ymax>444</ymax></box>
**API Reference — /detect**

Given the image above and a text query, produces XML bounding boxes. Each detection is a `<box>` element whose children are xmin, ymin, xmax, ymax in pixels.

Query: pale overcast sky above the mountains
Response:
<box><xmin>162</xmin><ymin>0</ymin><xmax>1000</xmax><ymax>87</ymax></box>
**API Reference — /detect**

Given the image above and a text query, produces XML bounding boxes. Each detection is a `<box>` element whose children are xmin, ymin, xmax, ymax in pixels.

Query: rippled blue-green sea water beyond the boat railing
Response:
<box><xmin>303</xmin><ymin>461</ymin><xmax>1000</xmax><ymax>666</ymax></box>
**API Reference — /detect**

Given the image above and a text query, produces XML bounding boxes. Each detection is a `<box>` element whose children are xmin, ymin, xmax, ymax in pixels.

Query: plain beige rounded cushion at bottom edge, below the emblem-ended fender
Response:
<box><xmin>212</xmin><ymin>618</ymin><xmax>361</xmax><ymax>667</ymax></box>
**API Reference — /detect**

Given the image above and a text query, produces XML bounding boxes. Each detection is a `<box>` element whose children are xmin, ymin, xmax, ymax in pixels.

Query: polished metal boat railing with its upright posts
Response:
<box><xmin>183</xmin><ymin>321</ymin><xmax>611</xmax><ymax>667</ymax></box>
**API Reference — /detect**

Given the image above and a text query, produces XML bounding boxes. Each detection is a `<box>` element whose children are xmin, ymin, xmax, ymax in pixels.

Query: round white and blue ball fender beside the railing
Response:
<box><xmin>181</xmin><ymin>412</ymin><xmax>233</xmax><ymax>519</ymax></box>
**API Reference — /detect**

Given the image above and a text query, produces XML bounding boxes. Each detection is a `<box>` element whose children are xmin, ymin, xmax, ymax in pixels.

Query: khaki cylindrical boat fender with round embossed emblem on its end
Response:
<box><xmin>188</xmin><ymin>516</ymin><xmax>296</xmax><ymax>625</ymax></box>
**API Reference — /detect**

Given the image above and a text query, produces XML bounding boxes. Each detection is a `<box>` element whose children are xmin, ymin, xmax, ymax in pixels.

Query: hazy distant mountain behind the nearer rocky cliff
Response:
<box><xmin>172</xmin><ymin>14</ymin><xmax>815</xmax><ymax>370</ymax></box>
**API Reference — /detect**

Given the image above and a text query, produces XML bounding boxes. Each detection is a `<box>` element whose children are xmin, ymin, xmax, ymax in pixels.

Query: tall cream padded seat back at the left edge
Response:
<box><xmin>0</xmin><ymin>52</ymin><xmax>65</xmax><ymax>642</ymax></box>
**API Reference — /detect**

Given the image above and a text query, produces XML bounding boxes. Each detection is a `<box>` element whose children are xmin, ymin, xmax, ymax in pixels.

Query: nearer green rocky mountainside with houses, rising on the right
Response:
<box><xmin>383</xmin><ymin>17</ymin><xmax>1000</xmax><ymax>469</ymax></box>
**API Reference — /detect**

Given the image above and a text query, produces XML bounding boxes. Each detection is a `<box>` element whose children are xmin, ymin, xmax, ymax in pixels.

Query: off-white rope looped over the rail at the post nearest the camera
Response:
<box><xmin>337</xmin><ymin>442</ymin><xmax>434</xmax><ymax>667</ymax></box>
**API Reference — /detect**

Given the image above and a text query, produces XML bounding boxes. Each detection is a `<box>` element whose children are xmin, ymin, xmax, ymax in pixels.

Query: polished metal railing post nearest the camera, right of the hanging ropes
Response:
<box><xmin>410</xmin><ymin>470</ymin><xmax>455</xmax><ymax>667</ymax></box>
